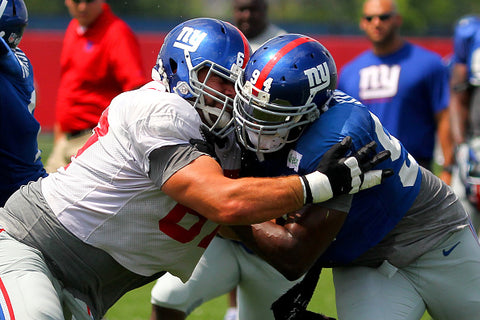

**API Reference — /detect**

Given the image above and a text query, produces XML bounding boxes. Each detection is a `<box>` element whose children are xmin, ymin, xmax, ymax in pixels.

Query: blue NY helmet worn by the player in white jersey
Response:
<box><xmin>152</xmin><ymin>18</ymin><xmax>251</xmax><ymax>137</ymax></box>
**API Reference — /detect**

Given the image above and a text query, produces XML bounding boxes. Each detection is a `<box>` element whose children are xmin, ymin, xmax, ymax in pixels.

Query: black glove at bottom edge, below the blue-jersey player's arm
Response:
<box><xmin>271</xmin><ymin>263</ymin><xmax>335</xmax><ymax>320</ymax></box>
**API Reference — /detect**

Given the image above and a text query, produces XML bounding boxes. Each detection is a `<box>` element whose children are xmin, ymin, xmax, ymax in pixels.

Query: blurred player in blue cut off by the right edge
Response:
<box><xmin>450</xmin><ymin>15</ymin><xmax>480</xmax><ymax>232</ymax></box>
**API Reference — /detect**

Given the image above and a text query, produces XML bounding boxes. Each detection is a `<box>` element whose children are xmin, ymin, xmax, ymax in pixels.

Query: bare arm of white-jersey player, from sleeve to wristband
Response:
<box><xmin>162</xmin><ymin>156</ymin><xmax>303</xmax><ymax>224</ymax></box>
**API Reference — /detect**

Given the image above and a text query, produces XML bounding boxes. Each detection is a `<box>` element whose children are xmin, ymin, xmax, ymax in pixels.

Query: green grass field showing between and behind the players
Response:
<box><xmin>38</xmin><ymin>134</ymin><xmax>432</xmax><ymax>320</ymax></box>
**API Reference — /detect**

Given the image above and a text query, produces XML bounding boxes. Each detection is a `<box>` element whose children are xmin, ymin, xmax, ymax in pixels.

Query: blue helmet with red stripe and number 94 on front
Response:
<box><xmin>234</xmin><ymin>34</ymin><xmax>337</xmax><ymax>153</ymax></box>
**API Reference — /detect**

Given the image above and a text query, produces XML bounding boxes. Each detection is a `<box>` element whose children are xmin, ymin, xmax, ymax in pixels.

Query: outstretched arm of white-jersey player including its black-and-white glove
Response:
<box><xmin>161</xmin><ymin>138</ymin><xmax>391</xmax><ymax>225</ymax></box>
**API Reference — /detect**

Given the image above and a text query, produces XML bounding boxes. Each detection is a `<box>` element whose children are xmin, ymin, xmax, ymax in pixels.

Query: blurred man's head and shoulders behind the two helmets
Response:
<box><xmin>233</xmin><ymin>0</ymin><xmax>286</xmax><ymax>51</ymax></box>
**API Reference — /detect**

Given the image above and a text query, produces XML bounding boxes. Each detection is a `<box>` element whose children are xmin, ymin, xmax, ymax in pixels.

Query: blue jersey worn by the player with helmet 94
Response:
<box><xmin>246</xmin><ymin>90</ymin><xmax>422</xmax><ymax>266</ymax></box>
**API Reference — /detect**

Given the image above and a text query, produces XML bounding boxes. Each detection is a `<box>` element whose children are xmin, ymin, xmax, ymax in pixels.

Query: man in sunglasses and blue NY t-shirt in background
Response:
<box><xmin>338</xmin><ymin>0</ymin><xmax>453</xmax><ymax>184</ymax></box>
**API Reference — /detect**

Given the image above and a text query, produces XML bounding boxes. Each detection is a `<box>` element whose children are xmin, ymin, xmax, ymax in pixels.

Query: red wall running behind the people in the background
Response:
<box><xmin>20</xmin><ymin>30</ymin><xmax>452</xmax><ymax>132</ymax></box>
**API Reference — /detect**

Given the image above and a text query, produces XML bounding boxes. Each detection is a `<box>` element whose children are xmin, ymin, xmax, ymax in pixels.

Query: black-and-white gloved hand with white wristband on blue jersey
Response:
<box><xmin>301</xmin><ymin>136</ymin><xmax>393</xmax><ymax>203</ymax></box>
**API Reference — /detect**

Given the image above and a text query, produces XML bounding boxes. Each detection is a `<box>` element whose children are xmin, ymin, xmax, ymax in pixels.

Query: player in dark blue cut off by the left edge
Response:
<box><xmin>0</xmin><ymin>0</ymin><xmax>47</xmax><ymax>207</ymax></box>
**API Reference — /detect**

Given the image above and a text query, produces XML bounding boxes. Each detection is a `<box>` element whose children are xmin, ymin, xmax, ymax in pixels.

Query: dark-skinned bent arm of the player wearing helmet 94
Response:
<box><xmin>222</xmin><ymin>205</ymin><xmax>347</xmax><ymax>280</ymax></box>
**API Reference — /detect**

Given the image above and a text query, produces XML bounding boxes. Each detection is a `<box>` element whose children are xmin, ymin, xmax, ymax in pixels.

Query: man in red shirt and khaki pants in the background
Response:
<box><xmin>45</xmin><ymin>0</ymin><xmax>147</xmax><ymax>172</ymax></box>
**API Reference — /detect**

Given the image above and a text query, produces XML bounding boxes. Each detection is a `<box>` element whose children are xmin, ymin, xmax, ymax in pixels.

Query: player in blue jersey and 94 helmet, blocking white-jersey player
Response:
<box><xmin>234</xmin><ymin>35</ymin><xmax>480</xmax><ymax>320</ymax></box>
